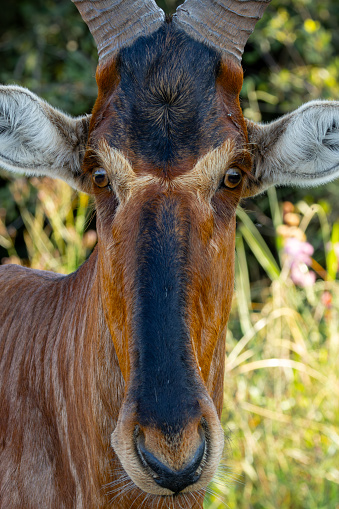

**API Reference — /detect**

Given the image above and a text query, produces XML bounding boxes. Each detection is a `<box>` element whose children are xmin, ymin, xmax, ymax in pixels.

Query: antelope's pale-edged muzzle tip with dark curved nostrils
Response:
<box><xmin>111</xmin><ymin>397</ymin><xmax>224</xmax><ymax>496</ymax></box>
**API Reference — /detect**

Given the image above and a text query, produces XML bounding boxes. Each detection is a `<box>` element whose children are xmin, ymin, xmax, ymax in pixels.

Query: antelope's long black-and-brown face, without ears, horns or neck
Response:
<box><xmin>84</xmin><ymin>24</ymin><xmax>251</xmax><ymax>495</ymax></box>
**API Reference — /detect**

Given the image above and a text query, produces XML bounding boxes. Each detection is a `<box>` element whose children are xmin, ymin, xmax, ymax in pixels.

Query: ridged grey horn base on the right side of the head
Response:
<box><xmin>173</xmin><ymin>0</ymin><xmax>271</xmax><ymax>65</ymax></box>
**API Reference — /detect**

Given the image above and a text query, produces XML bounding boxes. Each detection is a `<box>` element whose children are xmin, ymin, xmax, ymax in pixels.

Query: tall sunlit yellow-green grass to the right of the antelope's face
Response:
<box><xmin>204</xmin><ymin>192</ymin><xmax>339</xmax><ymax>509</ymax></box>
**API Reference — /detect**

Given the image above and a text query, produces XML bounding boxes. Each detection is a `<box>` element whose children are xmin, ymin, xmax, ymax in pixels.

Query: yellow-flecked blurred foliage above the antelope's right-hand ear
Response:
<box><xmin>242</xmin><ymin>0</ymin><xmax>339</xmax><ymax>121</ymax></box>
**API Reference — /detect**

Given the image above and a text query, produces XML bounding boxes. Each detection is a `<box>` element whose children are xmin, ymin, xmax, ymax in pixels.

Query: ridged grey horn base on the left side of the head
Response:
<box><xmin>72</xmin><ymin>0</ymin><xmax>165</xmax><ymax>63</ymax></box>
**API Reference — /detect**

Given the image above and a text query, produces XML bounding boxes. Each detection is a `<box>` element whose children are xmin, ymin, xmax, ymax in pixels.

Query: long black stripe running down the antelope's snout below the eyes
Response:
<box><xmin>135</xmin><ymin>199</ymin><xmax>202</xmax><ymax>430</ymax></box>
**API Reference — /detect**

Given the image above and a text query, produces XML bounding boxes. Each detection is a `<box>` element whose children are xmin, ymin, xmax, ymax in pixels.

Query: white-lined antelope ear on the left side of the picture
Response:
<box><xmin>0</xmin><ymin>86</ymin><xmax>90</xmax><ymax>192</ymax></box>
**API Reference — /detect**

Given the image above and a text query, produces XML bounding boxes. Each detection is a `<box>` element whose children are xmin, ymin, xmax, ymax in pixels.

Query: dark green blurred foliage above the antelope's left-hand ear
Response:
<box><xmin>0</xmin><ymin>0</ymin><xmax>97</xmax><ymax>115</ymax></box>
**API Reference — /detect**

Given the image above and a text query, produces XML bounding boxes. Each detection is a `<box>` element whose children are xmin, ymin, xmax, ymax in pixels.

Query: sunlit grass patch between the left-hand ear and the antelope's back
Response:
<box><xmin>0</xmin><ymin>178</ymin><xmax>96</xmax><ymax>274</ymax></box>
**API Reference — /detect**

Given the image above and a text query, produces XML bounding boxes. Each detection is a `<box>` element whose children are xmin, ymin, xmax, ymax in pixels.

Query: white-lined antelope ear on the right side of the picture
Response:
<box><xmin>244</xmin><ymin>101</ymin><xmax>339</xmax><ymax>197</ymax></box>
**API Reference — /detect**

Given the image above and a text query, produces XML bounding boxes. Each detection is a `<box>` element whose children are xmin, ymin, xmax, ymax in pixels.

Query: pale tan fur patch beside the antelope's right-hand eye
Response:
<box><xmin>176</xmin><ymin>140</ymin><xmax>240</xmax><ymax>196</ymax></box>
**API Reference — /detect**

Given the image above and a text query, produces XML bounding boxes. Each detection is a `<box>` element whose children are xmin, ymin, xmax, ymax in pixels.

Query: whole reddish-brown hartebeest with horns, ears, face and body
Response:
<box><xmin>0</xmin><ymin>0</ymin><xmax>339</xmax><ymax>509</ymax></box>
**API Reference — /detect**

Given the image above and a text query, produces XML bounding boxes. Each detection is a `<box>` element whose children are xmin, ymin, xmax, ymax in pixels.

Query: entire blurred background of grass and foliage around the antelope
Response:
<box><xmin>0</xmin><ymin>0</ymin><xmax>339</xmax><ymax>509</ymax></box>
